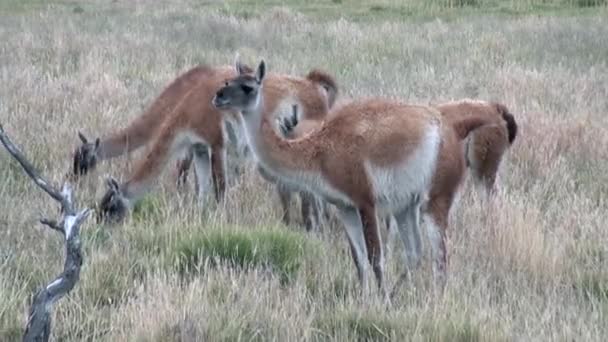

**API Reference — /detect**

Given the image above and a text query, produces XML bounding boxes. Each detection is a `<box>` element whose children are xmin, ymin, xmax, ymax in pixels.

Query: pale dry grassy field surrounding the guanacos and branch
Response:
<box><xmin>0</xmin><ymin>0</ymin><xmax>608</xmax><ymax>341</ymax></box>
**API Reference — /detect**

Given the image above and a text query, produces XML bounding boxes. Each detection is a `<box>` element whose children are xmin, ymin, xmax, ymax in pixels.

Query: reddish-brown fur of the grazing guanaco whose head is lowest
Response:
<box><xmin>95</xmin><ymin>66</ymin><xmax>338</xmax><ymax>224</ymax></box>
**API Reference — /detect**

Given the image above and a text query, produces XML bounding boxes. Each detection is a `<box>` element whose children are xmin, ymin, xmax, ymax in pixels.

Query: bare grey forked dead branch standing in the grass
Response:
<box><xmin>0</xmin><ymin>124</ymin><xmax>90</xmax><ymax>342</ymax></box>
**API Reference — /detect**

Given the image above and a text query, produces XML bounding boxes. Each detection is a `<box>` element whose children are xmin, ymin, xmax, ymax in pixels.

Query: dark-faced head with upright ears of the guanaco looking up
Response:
<box><xmin>213</xmin><ymin>60</ymin><xmax>266</xmax><ymax>111</ymax></box>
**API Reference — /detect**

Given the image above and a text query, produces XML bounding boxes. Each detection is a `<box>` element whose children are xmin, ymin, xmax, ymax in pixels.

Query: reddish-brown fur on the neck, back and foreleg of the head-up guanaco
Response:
<box><xmin>218</xmin><ymin>71</ymin><xmax>440</xmax><ymax>293</ymax></box>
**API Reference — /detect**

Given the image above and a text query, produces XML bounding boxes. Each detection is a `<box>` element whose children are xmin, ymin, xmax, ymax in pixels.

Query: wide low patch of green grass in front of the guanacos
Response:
<box><xmin>170</xmin><ymin>228</ymin><xmax>314</xmax><ymax>283</ymax></box>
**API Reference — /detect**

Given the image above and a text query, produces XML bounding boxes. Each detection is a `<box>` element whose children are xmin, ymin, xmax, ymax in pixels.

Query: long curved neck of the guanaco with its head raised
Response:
<box><xmin>242</xmin><ymin>94</ymin><xmax>317</xmax><ymax>175</ymax></box>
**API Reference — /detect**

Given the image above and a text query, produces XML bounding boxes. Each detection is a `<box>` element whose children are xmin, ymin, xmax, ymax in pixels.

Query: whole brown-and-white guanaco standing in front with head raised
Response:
<box><xmin>213</xmin><ymin>61</ymin><xmax>498</xmax><ymax>302</ymax></box>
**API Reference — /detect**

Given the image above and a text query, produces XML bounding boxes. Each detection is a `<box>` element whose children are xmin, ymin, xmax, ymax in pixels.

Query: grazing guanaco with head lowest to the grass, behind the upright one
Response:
<box><xmin>97</xmin><ymin>64</ymin><xmax>335</xmax><ymax>221</ymax></box>
